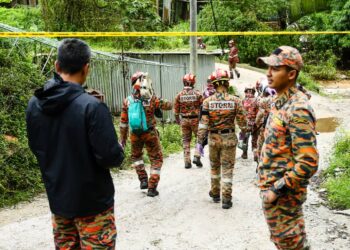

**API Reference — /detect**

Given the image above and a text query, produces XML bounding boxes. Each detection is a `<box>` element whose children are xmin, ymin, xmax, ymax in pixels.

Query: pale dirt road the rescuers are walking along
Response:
<box><xmin>0</xmin><ymin>65</ymin><xmax>350</xmax><ymax>250</ymax></box>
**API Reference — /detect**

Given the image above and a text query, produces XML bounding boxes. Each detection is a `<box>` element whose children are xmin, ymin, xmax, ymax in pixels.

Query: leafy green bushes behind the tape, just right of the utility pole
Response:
<box><xmin>198</xmin><ymin>1</ymin><xmax>290</xmax><ymax>65</ymax></box>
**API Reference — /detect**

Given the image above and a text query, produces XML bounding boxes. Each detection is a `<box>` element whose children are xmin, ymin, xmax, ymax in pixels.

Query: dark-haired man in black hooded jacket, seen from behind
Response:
<box><xmin>26</xmin><ymin>39</ymin><xmax>124</xmax><ymax>249</ymax></box>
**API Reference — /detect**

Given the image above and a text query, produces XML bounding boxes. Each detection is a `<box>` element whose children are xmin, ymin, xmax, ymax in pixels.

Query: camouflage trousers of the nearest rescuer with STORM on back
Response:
<box><xmin>209</xmin><ymin>133</ymin><xmax>237</xmax><ymax>201</ymax></box>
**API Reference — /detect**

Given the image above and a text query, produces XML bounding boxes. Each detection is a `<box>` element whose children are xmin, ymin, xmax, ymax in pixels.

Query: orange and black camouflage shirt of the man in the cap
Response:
<box><xmin>258</xmin><ymin>87</ymin><xmax>318</xmax><ymax>194</ymax></box>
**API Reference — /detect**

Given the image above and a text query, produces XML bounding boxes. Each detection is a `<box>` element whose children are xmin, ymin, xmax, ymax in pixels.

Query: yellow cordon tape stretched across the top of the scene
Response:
<box><xmin>0</xmin><ymin>31</ymin><xmax>350</xmax><ymax>38</ymax></box>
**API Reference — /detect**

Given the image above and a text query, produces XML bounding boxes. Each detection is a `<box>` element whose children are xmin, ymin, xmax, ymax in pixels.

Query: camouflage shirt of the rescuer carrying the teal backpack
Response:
<box><xmin>120</xmin><ymin>96</ymin><xmax>172</xmax><ymax>141</ymax></box>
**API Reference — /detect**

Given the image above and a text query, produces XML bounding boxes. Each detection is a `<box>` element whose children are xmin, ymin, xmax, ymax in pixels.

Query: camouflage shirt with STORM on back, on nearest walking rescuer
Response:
<box><xmin>198</xmin><ymin>93</ymin><xmax>246</xmax><ymax>143</ymax></box>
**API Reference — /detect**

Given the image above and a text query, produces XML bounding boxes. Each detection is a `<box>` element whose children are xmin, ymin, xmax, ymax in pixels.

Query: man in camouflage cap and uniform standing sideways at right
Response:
<box><xmin>258</xmin><ymin>46</ymin><xmax>319</xmax><ymax>250</ymax></box>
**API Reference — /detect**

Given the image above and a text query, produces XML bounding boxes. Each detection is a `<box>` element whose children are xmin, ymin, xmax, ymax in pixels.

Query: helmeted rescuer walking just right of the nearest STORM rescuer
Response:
<box><xmin>239</xmin><ymin>86</ymin><xmax>258</xmax><ymax>161</ymax></box>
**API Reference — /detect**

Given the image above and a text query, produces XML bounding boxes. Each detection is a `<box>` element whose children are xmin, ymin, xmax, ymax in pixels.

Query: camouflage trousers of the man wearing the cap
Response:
<box><xmin>263</xmin><ymin>194</ymin><xmax>309</xmax><ymax>250</ymax></box>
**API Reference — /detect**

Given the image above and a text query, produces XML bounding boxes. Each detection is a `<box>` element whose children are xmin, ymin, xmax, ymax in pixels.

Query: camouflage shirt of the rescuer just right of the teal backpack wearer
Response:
<box><xmin>174</xmin><ymin>87</ymin><xmax>203</xmax><ymax>116</ymax></box>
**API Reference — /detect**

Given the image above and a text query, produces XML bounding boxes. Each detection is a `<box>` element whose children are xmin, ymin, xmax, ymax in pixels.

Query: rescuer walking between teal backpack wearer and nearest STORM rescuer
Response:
<box><xmin>174</xmin><ymin>74</ymin><xmax>203</xmax><ymax>168</ymax></box>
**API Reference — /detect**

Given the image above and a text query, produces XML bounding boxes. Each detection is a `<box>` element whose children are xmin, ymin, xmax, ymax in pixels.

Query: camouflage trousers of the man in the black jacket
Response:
<box><xmin>52</xmin><ymin>207</ymin><xmax>117</xmax><ymax>250</ymax></box>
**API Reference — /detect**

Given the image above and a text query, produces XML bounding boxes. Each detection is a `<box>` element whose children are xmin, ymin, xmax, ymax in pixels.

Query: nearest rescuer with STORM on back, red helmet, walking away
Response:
<box><xmin>196</xmin><ymin>69</ymin><xmax>246</xmax><ymax>209</ymax></box>
